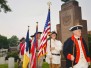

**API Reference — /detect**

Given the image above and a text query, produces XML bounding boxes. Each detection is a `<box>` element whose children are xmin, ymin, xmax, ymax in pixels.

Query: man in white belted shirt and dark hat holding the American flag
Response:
<box><xmin>46</xmin><ymin>31</ymin><xmax>62</xmax><ymax>68</ymax></box>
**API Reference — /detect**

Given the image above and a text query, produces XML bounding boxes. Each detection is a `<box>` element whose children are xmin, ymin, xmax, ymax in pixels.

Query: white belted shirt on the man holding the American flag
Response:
<box><xmin>46</xmin><ymin>39</ymin><xmax>62</xmax><ymax>64</ymax></box>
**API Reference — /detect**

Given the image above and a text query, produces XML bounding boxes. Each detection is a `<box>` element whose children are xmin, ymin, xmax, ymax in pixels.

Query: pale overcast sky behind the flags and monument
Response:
<box><xmin>0</xmin><ymin>0</ymin><xmax>91</xmax><ymax>38</ymax></box>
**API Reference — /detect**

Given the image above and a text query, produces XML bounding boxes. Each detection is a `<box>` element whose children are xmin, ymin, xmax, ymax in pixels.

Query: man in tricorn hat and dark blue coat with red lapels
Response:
<box><xmin>63</xmin><ymin>25</ymin><xmax>90</xmax><ymax>68</ymax></box>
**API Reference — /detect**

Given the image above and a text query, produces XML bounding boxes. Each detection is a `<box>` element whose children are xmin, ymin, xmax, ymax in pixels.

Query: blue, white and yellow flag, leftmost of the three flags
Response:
<box><xmin>23</xmin><ymin>29</ymin><xmax>29</xmax><ymax>68</ymax></box>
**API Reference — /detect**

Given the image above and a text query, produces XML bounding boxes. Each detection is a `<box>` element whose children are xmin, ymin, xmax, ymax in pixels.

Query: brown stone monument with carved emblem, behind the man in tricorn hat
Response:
<box><xmin>56</xmin><ymin>0</ymin><xmax>88</xmax><ymax>68</ymax></box>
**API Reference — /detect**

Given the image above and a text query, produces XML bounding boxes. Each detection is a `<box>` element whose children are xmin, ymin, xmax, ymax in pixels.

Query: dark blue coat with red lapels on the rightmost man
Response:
<box><xmin>63</xmin><ymin>37</ymin><xmax>90</xmax><ymax>68</ymax></box>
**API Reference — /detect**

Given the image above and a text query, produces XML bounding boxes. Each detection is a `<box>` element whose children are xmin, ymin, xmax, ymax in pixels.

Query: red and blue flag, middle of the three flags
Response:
<box><xmin>31</xmin><ymin>23</ymin><xmax>38</xmax><ymax>68</ymax></box>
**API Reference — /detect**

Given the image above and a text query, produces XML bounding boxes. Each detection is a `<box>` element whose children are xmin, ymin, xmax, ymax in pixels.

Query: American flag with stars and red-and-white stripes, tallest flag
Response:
<box><xmin>38</xmin><ymin>9</ymin><xmax>51</xmax><ymax>58</ymax></box>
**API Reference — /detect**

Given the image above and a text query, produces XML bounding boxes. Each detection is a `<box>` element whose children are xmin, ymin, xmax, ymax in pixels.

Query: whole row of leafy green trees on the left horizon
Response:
<box><xmin>0</xmin><ymin>35</ymin><xmax>19</xmax><ymax>49</ymax></box>
